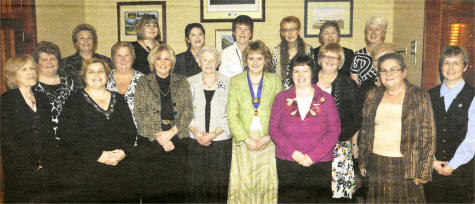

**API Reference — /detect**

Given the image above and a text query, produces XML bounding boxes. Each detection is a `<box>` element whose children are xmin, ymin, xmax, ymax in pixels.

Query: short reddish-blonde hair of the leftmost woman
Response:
<box><xmin>3</xmin><ymin>54</ymin><xmax>38</xmax><ymax>89</ymax></box>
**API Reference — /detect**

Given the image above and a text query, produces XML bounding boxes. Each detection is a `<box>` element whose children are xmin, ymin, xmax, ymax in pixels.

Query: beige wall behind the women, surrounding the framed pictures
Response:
<box><xmin>36</xmin><ymin>0</ymin><xmax>424</xmax><ymax>85</ymax></box>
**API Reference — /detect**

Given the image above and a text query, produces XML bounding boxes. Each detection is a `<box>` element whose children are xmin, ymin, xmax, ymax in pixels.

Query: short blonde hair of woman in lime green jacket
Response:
<box><xmin>242</xmin><ymin>40</ymin><xmax>272</xmax><ymax>72</ymax></box>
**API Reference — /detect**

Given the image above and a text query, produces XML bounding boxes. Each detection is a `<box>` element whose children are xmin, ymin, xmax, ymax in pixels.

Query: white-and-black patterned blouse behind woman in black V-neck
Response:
<box><xmin>106</xmin><ymin>70</ymin><xmax>144</xmax><ymax>127</ymax></box>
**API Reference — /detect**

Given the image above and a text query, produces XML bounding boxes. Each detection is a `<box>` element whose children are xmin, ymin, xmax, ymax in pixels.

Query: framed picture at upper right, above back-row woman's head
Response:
<box><xmin>304</xmin><ymin>0</ymin><xmax>353</xmax><ymax>38</ymax></box>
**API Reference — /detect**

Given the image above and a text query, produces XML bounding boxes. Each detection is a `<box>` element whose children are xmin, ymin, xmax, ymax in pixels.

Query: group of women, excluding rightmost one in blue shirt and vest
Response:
<box><xmin>1</xmin><ymin>15</ymin><xmax>473</xmax><ymax>203</ymax></box>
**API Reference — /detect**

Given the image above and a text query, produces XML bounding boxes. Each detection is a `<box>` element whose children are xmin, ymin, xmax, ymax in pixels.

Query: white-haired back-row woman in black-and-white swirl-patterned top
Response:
<box><xmin>350</xmin><ymin>16</ymin><xmax>388</xmax><ymax>84</ymax></box>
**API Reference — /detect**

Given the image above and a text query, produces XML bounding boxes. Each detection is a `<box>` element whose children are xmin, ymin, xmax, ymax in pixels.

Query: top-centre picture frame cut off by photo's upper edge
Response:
<box><xmin>200</xmin><ymin>0</ymin><xmax>265</xmax><ymax>22</ymax></box>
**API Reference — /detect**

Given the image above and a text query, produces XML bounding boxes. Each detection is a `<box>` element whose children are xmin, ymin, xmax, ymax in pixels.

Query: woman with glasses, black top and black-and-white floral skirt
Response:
<box><xmin>314</xmin><ymin>43</ymin><xmax>361</xmax><ymax>198</ymax></box>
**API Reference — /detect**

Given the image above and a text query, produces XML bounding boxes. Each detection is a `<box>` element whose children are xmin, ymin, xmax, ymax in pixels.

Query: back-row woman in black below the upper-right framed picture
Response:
<box><xmin>313</xmin><ymin>21</ymin><xmax>355</xmax><ymax>76</ymax></box>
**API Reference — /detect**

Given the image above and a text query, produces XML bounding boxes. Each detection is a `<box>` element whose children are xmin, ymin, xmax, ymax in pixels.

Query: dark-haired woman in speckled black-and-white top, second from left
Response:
<box><xmin>33</xmin><ymin>41</ymin><xmax>74</xmax><ymax>144</ymax></box>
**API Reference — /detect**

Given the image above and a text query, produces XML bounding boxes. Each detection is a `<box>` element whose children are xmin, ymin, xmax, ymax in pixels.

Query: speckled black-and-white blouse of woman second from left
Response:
<box><xmin>35</xmin><ymin>76</ymin><xmax>75</xmax><ymax>141</ymax></box>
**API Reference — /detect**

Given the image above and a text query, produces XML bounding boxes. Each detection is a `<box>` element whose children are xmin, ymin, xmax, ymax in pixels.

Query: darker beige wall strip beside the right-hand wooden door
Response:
<box><xmin>393</xmin><ymin>0</ymin><xmax>425</xmax><ymax>86</ymax></box>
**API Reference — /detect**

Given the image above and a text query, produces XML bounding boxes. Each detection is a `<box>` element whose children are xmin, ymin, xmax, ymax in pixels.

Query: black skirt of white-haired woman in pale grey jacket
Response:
<box><xmin>188</xmin><ymin>139</ymin><xmax>232</xmax><ymax>203</ymax></box>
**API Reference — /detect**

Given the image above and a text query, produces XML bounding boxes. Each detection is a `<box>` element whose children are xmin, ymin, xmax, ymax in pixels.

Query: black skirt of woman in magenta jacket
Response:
<box><xmin>276</xmin><ymin>158</ymin><xmax>335</xmax><ymax>203</ymax></box>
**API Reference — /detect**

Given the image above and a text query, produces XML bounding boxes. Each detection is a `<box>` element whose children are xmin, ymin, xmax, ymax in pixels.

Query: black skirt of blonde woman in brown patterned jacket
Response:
<box><xmin>138</xmin><ymin>136</ymin><xmax>190</xmax><ymax>203</ymax></box>
